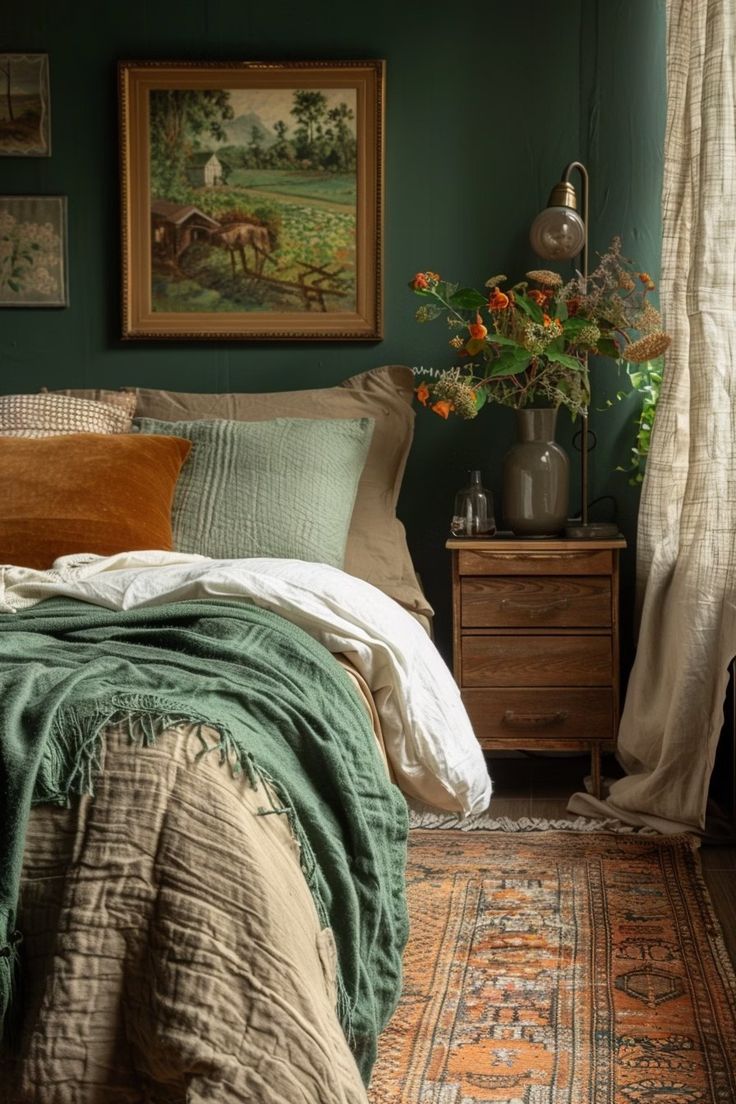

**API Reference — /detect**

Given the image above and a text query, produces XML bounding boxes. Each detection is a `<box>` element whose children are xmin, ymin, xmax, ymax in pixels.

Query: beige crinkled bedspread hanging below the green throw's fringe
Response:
<box><xmin>0</xmin><ymin>728</ymin><xmax>366</xmax><ymax>1104</ymax></box>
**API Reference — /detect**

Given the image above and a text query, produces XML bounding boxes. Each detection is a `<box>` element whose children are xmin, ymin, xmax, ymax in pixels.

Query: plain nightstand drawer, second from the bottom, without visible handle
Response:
<box><xmin>460</xmin><ymin>634</ymin><xmax>612</xmax><ymax>689</ymax></box>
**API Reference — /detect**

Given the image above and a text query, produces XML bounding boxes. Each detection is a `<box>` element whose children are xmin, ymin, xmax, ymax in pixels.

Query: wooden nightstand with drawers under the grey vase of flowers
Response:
<box><xmin>446</xmin><ymin>537</ymin><xmax>626</xmax><ymax>797</ymax></box>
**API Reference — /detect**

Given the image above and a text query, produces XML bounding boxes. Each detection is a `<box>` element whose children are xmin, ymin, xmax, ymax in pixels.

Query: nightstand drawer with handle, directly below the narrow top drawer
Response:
<box><xmin>460</xmin><ymin>575</ymin><xmax>611</xmax><ymax>628</ymax></box>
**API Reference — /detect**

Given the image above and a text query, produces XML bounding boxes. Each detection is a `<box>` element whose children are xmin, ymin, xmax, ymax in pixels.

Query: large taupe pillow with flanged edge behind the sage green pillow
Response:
<box><xmin>130</xmin><ymin>364</ymin><xmax>433</xmax><ymax>616</ymax></box>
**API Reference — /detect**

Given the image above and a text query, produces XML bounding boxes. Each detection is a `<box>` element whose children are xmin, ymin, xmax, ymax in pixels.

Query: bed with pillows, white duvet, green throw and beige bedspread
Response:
<box><xmin>0</xmin><ymin>368</ymin><xmax>490</xmax><ymax>1104</ymax></box>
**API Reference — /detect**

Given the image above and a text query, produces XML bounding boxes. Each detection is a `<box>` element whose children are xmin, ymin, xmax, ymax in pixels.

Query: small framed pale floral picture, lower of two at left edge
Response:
<box><xmin>0</xmin><ymin>195</ymin><xmax>68</xmax><ymax>307</ymax></box>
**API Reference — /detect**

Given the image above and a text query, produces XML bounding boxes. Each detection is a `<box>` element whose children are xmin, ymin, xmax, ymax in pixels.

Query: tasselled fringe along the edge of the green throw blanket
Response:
<box><xmin>30</xmin><ymin>694</ymin><xmax>355</xmax><ymax>1047</ymax></box>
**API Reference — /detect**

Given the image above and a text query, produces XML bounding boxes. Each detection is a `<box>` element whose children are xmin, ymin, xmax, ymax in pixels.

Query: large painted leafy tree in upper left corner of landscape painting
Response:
<box><xmin>150</xmin><ymin>88</ymin><xmax>234</xmax><ymax>199</ymax></box>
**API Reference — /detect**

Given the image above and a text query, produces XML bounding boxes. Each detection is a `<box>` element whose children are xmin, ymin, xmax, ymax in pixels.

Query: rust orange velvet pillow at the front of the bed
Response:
<box><xmin>0</xmin><ymin>433</ymin><xmax>192</xmax><ymax>570</ymax></box>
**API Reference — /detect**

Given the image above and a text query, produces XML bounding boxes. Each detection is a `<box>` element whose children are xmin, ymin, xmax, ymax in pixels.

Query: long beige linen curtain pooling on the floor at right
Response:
<box><xmin>569</xmin><ymin>0</ymin><xmax>736</xmax><ymax>831</ymax></box>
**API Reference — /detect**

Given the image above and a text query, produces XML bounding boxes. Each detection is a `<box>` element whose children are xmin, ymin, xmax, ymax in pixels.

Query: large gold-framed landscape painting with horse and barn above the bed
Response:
<box><xmin>119</xmin><ymin>61</ymin><xmax>384</xmax><ymax>341</ymax></box>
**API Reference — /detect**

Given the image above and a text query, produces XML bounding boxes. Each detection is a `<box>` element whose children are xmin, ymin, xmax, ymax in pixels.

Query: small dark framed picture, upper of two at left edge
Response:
<box><xmin>0</xmin><ymin>54</ymin><xmax>51</xmax><ymax>157</ymax></box>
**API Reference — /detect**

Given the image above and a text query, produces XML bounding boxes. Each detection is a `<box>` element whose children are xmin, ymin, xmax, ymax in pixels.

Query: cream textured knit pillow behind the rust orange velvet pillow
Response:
<box><xmin>0</xmin><ymin>392</ymin><xmax>132</xmax><ymax>437</ymax></box>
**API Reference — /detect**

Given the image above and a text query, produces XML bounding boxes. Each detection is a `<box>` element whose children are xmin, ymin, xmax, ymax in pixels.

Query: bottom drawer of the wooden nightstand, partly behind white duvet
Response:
<box><xmin>462</xmin><ymin>689</ymin><xmax>614</xmax><ymax>747</ymax></box>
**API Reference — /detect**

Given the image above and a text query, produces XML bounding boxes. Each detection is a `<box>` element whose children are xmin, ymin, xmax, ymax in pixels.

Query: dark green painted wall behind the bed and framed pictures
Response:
<box><xmin>0</xmin><ymin>0</ymin><xmax>664</xmax><ymax>666</ymax></box>
